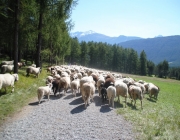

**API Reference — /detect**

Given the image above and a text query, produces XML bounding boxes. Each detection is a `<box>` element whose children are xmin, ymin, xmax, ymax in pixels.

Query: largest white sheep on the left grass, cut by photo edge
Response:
<box><xmin>0</xmin><ymin>73</ymin><xmax>19</xmax><ymax>93</ymax></box>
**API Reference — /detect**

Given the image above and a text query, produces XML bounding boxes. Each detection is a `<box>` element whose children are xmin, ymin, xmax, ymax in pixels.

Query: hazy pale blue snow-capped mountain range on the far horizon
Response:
<box><xmin>70</xmin><ymin>30</ymin><xmax>142</xmax><ymax>44</ymax></box>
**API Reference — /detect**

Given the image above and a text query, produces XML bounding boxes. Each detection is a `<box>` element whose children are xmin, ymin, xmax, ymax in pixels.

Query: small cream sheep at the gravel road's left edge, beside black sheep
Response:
<box><xmin>37</xmin><ymin>83</ymin><xmax>52</xmax><ymax>104</ymax></box>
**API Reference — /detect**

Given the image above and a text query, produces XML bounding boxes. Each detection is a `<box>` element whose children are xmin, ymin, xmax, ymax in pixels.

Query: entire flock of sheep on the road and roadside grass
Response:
<box><xmin>0</xmin><ymin>61</ymin><xmax>160</xmax><ymax>108</ymax></box>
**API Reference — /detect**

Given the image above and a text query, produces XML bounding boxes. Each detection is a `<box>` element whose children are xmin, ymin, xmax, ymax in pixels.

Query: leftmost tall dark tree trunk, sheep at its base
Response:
<box><xmin>14</xmin><ymin>0</ymin><xmax>19</xmax><ymax>73</ymax></box>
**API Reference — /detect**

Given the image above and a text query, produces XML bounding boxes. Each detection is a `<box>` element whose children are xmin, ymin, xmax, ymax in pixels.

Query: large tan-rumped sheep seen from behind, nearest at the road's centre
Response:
<box><xmin>82</xmin><ymin>82</ymin><xmax>95</xmax><ymax>108</ymax></box>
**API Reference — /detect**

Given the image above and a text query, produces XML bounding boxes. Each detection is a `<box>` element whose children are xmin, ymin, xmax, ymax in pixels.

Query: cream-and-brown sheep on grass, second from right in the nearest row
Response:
<box><xmin>128</xmin><ymin>83</ymin><xmax>143</xmax><ymax>109</ymax></box>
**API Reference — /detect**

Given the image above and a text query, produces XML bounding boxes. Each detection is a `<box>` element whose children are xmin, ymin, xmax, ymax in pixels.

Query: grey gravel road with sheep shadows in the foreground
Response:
<box><xmin>0</xmin><ymin>90</ymin><xmax>135</xmax><ymax>140</ymax></box>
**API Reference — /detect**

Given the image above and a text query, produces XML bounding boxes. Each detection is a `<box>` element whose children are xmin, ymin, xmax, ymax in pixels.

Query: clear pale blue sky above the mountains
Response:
<box><xmin>71</xmin><ymin>0</ymin><xmax>180</xmax><ymax>38</ymax></box>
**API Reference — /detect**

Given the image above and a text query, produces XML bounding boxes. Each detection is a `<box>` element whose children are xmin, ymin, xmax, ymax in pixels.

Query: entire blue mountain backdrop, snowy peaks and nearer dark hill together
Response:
<box><xmin>71</xmin><ymin>30</ymin><xmax>180</xmax><ymax>67</ymax></box>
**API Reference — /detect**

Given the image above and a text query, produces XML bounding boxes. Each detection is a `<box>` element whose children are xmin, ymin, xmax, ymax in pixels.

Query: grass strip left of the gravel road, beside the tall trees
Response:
<box><xmin>0</xmin><ymin>68</ymin><xmax>47</xmax><ymax>124</ymax></box>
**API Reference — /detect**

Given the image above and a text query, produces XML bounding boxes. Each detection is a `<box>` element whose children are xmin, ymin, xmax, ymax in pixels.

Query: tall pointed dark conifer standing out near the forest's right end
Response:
<box><xmin>140</xmin><ymin>50</ymin><xmax>147</xmax><ymax>75</ymax></box>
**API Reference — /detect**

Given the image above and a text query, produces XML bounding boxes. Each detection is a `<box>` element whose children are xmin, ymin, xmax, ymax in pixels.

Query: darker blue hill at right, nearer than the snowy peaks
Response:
<box><xmin>119</xmin><ymin>35</ymin><xmax>180</xmax><ymax>67</ymax></box>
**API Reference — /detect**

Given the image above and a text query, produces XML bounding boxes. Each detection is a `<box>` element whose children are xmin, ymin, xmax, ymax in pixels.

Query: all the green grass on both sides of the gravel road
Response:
<box><xmin>0</xmin><ymin>68</ymin><xmax>180</xmax><ymax>140</ymax></box>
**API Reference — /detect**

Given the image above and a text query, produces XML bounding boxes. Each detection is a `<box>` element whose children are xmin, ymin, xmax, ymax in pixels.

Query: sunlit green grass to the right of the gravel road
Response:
<box><xmin>116</xmin><ymin>76</ymin><xmax>180</xmax><ymax>140</ymax></box>
